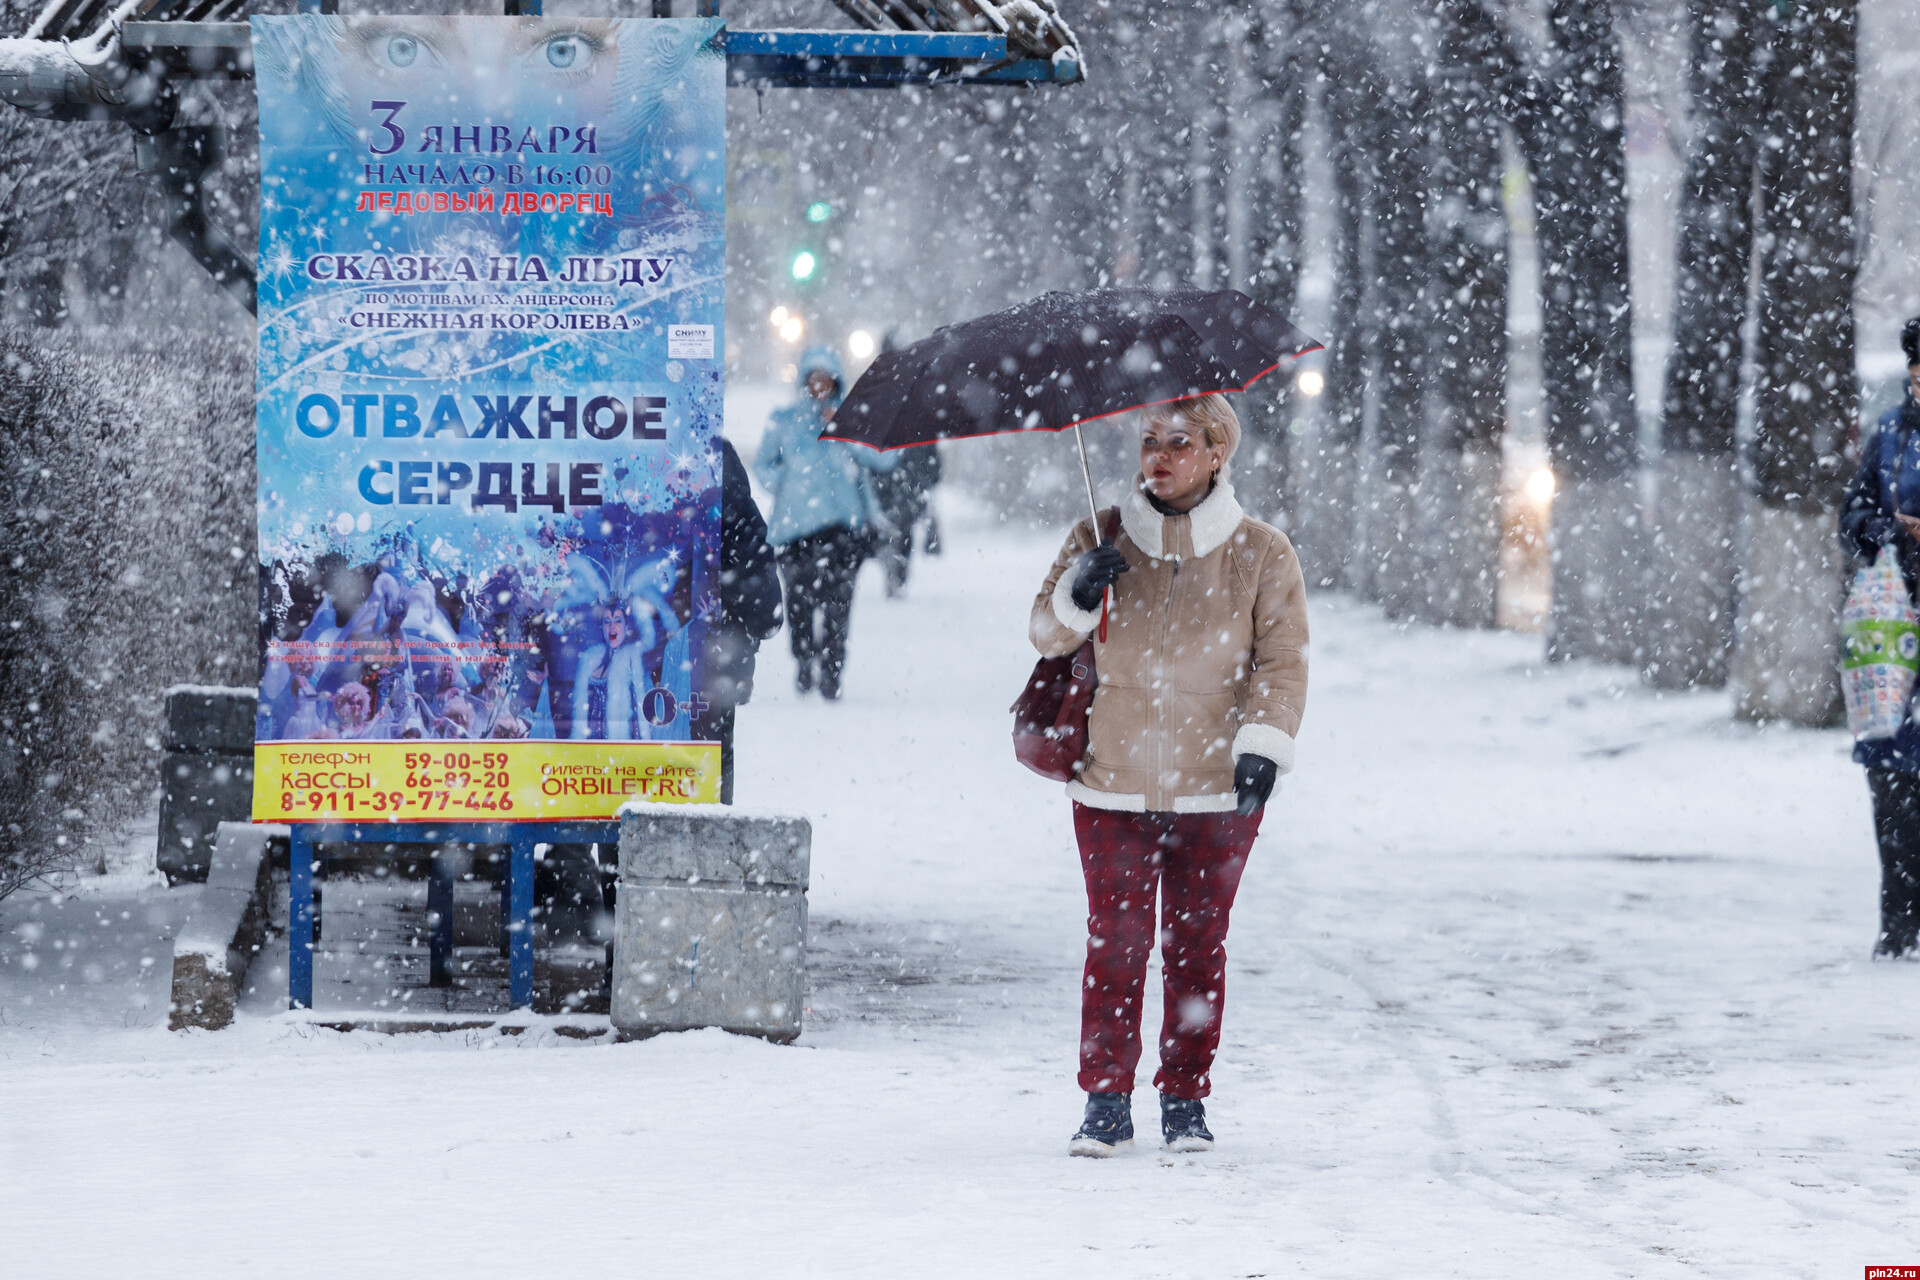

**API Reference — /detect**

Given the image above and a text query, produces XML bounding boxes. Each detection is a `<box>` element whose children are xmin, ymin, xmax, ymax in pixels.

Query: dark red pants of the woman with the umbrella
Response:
<box><xmin>1073</xmin><ymin>802</ymin><xmax>1263</xmax><ymax>1098</ymax></box>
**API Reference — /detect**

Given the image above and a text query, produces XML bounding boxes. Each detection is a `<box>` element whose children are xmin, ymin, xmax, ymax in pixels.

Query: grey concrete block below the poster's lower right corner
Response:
<box><xmin>611</xmin><ymin>804</ymin><xmax>812</xmax><ymax>1042</ymax></box>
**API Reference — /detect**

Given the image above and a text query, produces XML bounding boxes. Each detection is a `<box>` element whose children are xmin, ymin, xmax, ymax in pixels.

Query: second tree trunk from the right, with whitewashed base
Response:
<box><xmin>1644</xmin><ymin>0</ymin><xmax>1761</xmax><ymax>689</ymax></box>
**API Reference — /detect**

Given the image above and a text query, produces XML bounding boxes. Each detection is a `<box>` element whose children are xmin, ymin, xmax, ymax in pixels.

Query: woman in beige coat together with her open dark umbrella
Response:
<box><xmin>833</xmin><ymin>286</ymin><xmax>1319</xmax><ymax>1155</ymax></box>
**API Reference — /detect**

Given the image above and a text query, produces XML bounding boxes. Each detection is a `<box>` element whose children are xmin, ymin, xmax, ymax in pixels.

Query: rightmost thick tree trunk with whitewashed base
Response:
<box><xmin>1732</xmin><ymin>0</ymin><xmax>1859</xmax><ymax>725</ymax></box>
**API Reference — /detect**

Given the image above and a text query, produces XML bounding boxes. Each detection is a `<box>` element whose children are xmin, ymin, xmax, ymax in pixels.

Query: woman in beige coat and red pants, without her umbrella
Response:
<box><xmin>1029</xmin><ymin>395</ymin><xmax>1308</xmax><ymax>1155</ymax></box>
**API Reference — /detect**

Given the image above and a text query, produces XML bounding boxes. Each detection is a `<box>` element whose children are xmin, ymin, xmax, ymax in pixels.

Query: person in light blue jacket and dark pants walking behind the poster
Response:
<box><xmin>753</xmin><ymin>347</ymin><xmax>899</xmax><ymax>702</ymax></box>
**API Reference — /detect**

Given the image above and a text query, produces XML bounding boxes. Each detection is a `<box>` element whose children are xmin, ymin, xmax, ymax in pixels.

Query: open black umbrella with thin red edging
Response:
<box><xmin>826</xmin><ymin>286</ymin><xmax>1319</xmax><ymax>524</ymax></box>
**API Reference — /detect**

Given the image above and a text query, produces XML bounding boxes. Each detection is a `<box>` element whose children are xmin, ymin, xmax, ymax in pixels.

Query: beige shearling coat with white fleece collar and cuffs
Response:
<box><xmin>1029</xmin><ymin>478</ymin><xmax>1308</xmax><ymax>814</ymax></box>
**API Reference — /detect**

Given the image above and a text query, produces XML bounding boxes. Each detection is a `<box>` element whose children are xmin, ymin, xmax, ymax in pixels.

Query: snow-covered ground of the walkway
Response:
<box><xmin>0</xmin><ymin>510</ymin><xmax>1920</xmax><ymax>1280</ymax></box>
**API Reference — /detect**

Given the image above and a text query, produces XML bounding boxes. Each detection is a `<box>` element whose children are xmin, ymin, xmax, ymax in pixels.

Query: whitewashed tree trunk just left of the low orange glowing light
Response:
<box><xmin>1415</xmin><ymin>10</ymin><xmax>1507</xmax><ymax>628</ymax></box>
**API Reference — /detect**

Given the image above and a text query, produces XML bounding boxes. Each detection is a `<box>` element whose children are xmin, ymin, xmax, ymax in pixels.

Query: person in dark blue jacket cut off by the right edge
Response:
<box><xmin>1839</xmin><ymin>317</ymin><xmax>1920</xmax><ymax>958</ymax></box>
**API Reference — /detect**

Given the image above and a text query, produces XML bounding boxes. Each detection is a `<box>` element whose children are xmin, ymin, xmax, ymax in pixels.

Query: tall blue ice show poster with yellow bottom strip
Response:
<box><xmin>252</xmin><ymin>13</ymin><xmax>726</xmax><ymax>821</ymax></box>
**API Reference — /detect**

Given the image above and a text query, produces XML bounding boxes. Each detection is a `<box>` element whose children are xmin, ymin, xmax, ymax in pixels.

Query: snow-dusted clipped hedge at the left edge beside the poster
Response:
<box><xmin>0</xmin><ymin>328</ymin><xmax>259</xmax><ymax>898</ymax></box>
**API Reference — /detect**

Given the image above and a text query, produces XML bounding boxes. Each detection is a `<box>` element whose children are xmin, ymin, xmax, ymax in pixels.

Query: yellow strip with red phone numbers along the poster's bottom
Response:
<box><xmin>253</xmin><ymin>739</ymin><xmax>720</xmax><ymax>821</ymax></box>
